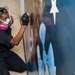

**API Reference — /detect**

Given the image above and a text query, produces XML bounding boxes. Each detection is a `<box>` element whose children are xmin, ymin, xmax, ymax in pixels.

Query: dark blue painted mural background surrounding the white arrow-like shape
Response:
<box><xmin>43</xmin><ymin>0</ymin><xmax>75</xmax><ymax>75</ymax></box>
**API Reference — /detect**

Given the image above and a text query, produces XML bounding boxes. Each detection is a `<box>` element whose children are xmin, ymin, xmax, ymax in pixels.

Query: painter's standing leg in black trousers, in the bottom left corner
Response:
<box><xmin>0</xmin><ymin>58</ymin><xmax>10</xmax><ymax>75</ymax></box>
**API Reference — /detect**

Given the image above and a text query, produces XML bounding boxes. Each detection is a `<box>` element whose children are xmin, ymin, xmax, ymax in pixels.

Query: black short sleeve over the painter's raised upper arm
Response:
<box><xmin>0</xmin><ymin>30</ymin><xmax>13</xmax><ymax>47</ymax></box>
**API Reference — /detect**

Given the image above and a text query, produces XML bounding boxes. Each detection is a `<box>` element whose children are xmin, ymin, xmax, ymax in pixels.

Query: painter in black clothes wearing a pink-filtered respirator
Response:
<box><xmin>0</xmin><ymin>7</ymin><xmax>29</xmax><ymax>75</ymax></box>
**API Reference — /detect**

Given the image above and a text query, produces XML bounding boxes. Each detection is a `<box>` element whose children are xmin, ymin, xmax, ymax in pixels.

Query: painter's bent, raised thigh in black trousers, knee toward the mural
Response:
<box><xmin>6</xmin><ymin>51</ymin><xmax>27</xmax><ymax>72</ymax></box>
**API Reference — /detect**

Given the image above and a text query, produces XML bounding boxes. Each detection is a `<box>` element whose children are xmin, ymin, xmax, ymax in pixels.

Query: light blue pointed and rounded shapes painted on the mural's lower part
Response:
<box><xmin>37</xmin><ymin>22</ymin><xmax>54</xmax><ymax>75</ymax></box>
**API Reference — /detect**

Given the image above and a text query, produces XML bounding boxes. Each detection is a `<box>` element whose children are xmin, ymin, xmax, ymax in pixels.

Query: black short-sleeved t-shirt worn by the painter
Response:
<box><xmin>0</xmin><ymin>28</ymin><xmax>13</xmax><ymax>51</ymax></box>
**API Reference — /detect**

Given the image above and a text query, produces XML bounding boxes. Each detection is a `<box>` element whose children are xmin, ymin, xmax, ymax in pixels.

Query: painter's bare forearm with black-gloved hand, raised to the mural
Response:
<box><xmin>10</xmin><ymin>13</ymin><xmax>29</xmax><ymax>45</ymax></box>
